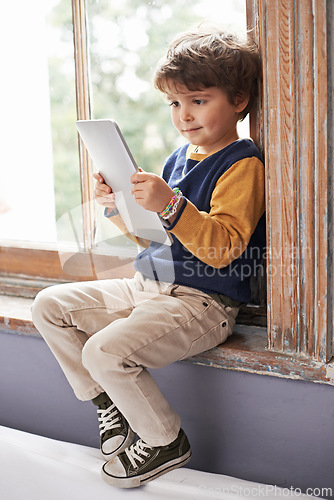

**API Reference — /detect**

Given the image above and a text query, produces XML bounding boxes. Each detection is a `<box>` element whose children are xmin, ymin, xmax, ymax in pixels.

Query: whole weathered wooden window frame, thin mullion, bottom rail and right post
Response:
<box><xmin>0</xmin><ymin>0</ymin><xmax>334</xmax><ymax>371</ymax></box>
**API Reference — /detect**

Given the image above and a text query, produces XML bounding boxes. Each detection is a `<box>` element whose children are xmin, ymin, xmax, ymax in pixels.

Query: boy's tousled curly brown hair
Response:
<box><xmin>154</xmin><ymin>26</ymin><xmax>261</xmax><ymax>120</ymax></box>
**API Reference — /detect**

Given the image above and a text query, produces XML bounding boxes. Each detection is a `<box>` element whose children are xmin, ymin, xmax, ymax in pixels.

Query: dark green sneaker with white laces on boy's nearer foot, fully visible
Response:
<box><xmin>102</xmin><ymin>429</ymin><xmax>191</xmax><ymax>488</ymax></box>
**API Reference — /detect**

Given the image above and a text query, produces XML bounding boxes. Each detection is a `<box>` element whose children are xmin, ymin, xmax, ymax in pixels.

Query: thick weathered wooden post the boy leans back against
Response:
<box><xmin>249</xmin><ymin>0</ymin><xmax>334</xmax><ymax>363</ymax></box>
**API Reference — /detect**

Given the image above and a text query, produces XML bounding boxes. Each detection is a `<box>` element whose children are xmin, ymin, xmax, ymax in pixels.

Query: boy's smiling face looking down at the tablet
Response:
<box><xmin>167</xmin><ymin>84</ymin><xmax>247</xmax><ymax>154</ymax></box>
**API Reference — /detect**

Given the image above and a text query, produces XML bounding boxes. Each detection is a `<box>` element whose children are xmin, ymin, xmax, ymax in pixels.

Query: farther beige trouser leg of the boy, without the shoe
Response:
<box><xmin>32</xmin><ymin>279</ymin><xmax>142</xmax><ymax>401</ymax></box>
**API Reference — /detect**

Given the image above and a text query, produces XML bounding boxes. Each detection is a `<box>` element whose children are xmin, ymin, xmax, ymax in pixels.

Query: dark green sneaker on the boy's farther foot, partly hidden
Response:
<box><xmin>93</xmin><ymin>392</ymin><xmax>136</xmax><ymax>460</ymax></box>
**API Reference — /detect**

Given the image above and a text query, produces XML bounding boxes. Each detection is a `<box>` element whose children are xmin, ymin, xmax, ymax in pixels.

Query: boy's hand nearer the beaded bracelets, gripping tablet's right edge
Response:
<box><xmin>130</xmin><ymin>171</ymin><xmax>174</xmax><ymax>212</ymax></box>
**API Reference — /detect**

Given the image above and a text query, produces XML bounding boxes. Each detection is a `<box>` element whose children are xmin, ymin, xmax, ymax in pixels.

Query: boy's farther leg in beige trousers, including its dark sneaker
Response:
<box><xmin>32</xmin><ymin>278</ymin><xmax>164</xmax><ymax>460</ymax></box>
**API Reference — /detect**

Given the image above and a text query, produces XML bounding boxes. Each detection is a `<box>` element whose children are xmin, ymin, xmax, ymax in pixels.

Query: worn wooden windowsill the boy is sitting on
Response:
<box><xmin>0</xmin><ymin>296</ymin><xmax>334</xmax><ymax>385</ymax></box>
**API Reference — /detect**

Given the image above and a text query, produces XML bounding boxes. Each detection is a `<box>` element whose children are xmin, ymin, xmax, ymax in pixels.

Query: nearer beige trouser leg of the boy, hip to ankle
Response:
<box><xmin>82</xmin><ymin>280</ymin><xmax>238</xmax><ymax>447</ymax></box>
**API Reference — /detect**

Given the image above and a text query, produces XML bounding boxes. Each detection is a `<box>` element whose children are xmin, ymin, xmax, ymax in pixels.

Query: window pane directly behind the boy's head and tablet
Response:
<box><xmin>87</xmin><ymin>0</ymin><xmax>249</xmax><ymax>249</ymax></box>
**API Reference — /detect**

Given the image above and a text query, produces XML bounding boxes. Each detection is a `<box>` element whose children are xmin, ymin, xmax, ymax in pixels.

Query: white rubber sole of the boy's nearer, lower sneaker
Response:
<box><xmin>101</xmin><ymin>450</ymin><xmax>191</xmax><ymax>488</ymax></box>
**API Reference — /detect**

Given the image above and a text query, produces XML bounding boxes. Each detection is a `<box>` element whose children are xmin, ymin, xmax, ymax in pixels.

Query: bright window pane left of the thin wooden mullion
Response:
<box><xmin>0</xmin><ymin>0</ymin><xmax>80</xmax><ymax>246</ymax></box>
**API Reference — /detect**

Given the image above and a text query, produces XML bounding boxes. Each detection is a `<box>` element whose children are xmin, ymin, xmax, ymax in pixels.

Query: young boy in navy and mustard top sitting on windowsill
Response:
<box><xmin>32</xmin><ymin>29</ymin><xmax>265</xmax><ymax>488</ymax></box>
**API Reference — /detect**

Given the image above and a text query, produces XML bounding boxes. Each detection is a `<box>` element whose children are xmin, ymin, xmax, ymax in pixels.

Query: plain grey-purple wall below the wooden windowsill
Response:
<box><xmin>0</xmin><ymin>333</ymin><xmax>334</xmax><ymax>493</ymax></box>
